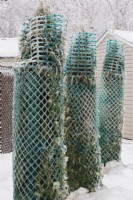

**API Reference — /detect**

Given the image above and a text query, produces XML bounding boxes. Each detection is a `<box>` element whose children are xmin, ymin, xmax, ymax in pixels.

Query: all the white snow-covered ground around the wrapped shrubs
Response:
<box><xmin>0</xmin><ymin>140</ymin><xmax>133</xmax><ymax>200</ymax></box>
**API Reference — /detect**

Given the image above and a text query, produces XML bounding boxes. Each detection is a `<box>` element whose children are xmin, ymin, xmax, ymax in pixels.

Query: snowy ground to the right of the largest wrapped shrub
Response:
<box><xmin>67</xmin><ymin>140</ymin><xmax>133</xmax><ymax>200</ymax></box>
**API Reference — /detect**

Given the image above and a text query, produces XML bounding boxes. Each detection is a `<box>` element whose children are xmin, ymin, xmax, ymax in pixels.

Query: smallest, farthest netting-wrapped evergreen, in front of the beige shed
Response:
<box><xmin>98</xmin><ymin>40</ymin><xmax>124</xmax><ymax>164</ymax></box>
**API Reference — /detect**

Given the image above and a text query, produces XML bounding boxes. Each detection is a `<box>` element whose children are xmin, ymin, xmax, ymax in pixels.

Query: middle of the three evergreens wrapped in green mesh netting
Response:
<box><xmin>63</xmin><ymin>32</ymin><xmax>101</xmax><ymax>192</ymax></box>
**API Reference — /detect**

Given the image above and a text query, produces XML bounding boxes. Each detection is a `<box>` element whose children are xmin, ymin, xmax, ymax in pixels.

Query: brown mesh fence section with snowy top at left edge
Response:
<box><xmin>0</xmin><ymin>67</ymin><xmax>13</xmax><ymax>153</ymax></box>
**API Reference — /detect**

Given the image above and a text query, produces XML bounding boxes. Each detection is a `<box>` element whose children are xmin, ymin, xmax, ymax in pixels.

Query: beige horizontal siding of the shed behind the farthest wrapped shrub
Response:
<box><xmin>96</xmin><ymin>34</ymin><xmax>133</xmax><ymax>139</ymax></box>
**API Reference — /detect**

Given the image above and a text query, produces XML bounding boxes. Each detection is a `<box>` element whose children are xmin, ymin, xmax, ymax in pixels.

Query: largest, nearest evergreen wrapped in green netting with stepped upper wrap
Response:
<box><xmin>13</xmin><ymin>1</ymin><xmax>68</xmax><ymax>200</ymax></box>
